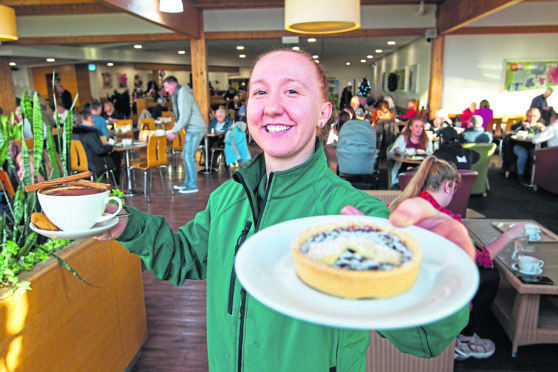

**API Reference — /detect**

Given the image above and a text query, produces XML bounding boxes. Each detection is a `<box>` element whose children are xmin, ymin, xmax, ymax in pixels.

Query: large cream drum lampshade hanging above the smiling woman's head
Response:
<box><xmin>285</xmin><ymin>0</ymin><xmax>360</xmax><ymax>34</ymax></box>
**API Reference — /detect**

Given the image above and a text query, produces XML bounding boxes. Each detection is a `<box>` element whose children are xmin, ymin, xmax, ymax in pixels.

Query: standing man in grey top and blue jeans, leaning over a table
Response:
<box><xmin>163</xmin><ymin>75</ymin><xmax>207</xmax><ymax>194</ymax></box>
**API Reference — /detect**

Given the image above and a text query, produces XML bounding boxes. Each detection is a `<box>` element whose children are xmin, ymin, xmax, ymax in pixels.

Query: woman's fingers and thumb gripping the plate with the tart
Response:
<box><xmin>341</xmin><ymin>198</ymin><xmax>475</xmax><ymax>260</ymax></box>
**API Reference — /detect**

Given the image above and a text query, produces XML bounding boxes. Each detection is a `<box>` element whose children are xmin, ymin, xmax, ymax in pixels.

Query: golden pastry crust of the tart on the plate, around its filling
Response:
<box><xmin>291</xmin><ymin>222</ymin><xmax>423</xmax><ymax>299</ymax></box>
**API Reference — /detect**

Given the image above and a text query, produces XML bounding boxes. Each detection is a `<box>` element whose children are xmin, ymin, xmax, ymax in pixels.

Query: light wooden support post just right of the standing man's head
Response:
<box><xmin>190</xmin><ymin>17</ymin><xmax>209</xmax><ymax>125</ymax></box>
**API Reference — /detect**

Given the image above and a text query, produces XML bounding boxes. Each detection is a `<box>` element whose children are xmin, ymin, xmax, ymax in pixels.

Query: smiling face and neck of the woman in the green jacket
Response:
<box><xmin>246</xmin><ymin>51</ymin><xmax>331</xmax><ymax>172</ymax></box>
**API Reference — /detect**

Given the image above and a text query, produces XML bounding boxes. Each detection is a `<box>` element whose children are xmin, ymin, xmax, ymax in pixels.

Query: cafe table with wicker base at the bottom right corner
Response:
<box><xmin>464</xmin><ymin>219</ymin><xmax>558</xmax><ymax>357</ymax></box>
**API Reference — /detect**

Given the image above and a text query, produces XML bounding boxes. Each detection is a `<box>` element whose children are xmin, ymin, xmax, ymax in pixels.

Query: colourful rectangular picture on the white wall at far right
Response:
<box><xmin>504</xmin><ymin>61</ymin><xmax>558</xmax><ymax>91</ymax></box>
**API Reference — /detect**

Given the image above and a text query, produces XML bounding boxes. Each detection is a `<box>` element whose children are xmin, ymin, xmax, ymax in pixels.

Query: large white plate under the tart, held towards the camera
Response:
<box><xmin>235</xmin><ymin>215</ymin><xmax>479</xmax><ymax>330</ymax></box>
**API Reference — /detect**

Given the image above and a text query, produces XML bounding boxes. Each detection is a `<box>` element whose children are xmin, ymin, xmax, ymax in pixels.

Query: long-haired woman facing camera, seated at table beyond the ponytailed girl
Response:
<box><xmin>387</xmin><ymin>116</ymin><xmax>434</xmax><ymax>185</ymax></box>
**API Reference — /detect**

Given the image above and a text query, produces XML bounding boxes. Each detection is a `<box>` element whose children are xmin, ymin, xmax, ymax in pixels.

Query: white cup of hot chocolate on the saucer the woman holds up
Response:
<box><xmin>37</xmin><ymin>186</ymin><xmax>122</xmax><ymax>231</ymax></box>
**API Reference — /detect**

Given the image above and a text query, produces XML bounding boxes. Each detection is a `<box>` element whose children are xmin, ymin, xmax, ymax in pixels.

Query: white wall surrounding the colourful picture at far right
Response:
<box><xmin>442</xmin><ymin>34</ymin><xmax>558</xmax><ymax>116</ymax></box>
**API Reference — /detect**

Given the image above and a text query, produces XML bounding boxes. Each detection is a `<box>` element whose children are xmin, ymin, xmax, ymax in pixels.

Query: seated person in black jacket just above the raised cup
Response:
<box><xmin>72</xmin><ymin>110</ymin><xmax>122</xmax><ymax>184</ymax></box>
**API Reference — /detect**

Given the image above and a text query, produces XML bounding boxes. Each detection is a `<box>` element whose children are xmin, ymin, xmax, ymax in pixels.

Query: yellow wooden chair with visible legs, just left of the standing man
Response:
<box><xmin>130</xmin><ymin>136</ymin><xmax>174</xmax><ymax>203</ymax></box>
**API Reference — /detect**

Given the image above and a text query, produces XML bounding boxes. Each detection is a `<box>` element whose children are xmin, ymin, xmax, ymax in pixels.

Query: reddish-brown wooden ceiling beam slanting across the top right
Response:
<box><xmin>437</xmin><ymin>0</ymin><xmax>523</xmax><ymax>35</ymax></box>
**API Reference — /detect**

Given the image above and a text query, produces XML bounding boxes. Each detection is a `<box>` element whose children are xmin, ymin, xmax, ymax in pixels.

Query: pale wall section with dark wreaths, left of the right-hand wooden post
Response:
<box><xmin>374</xmin><ymin>38</ymin><xmax>431</xmax><ymax>107</ymax></box>
